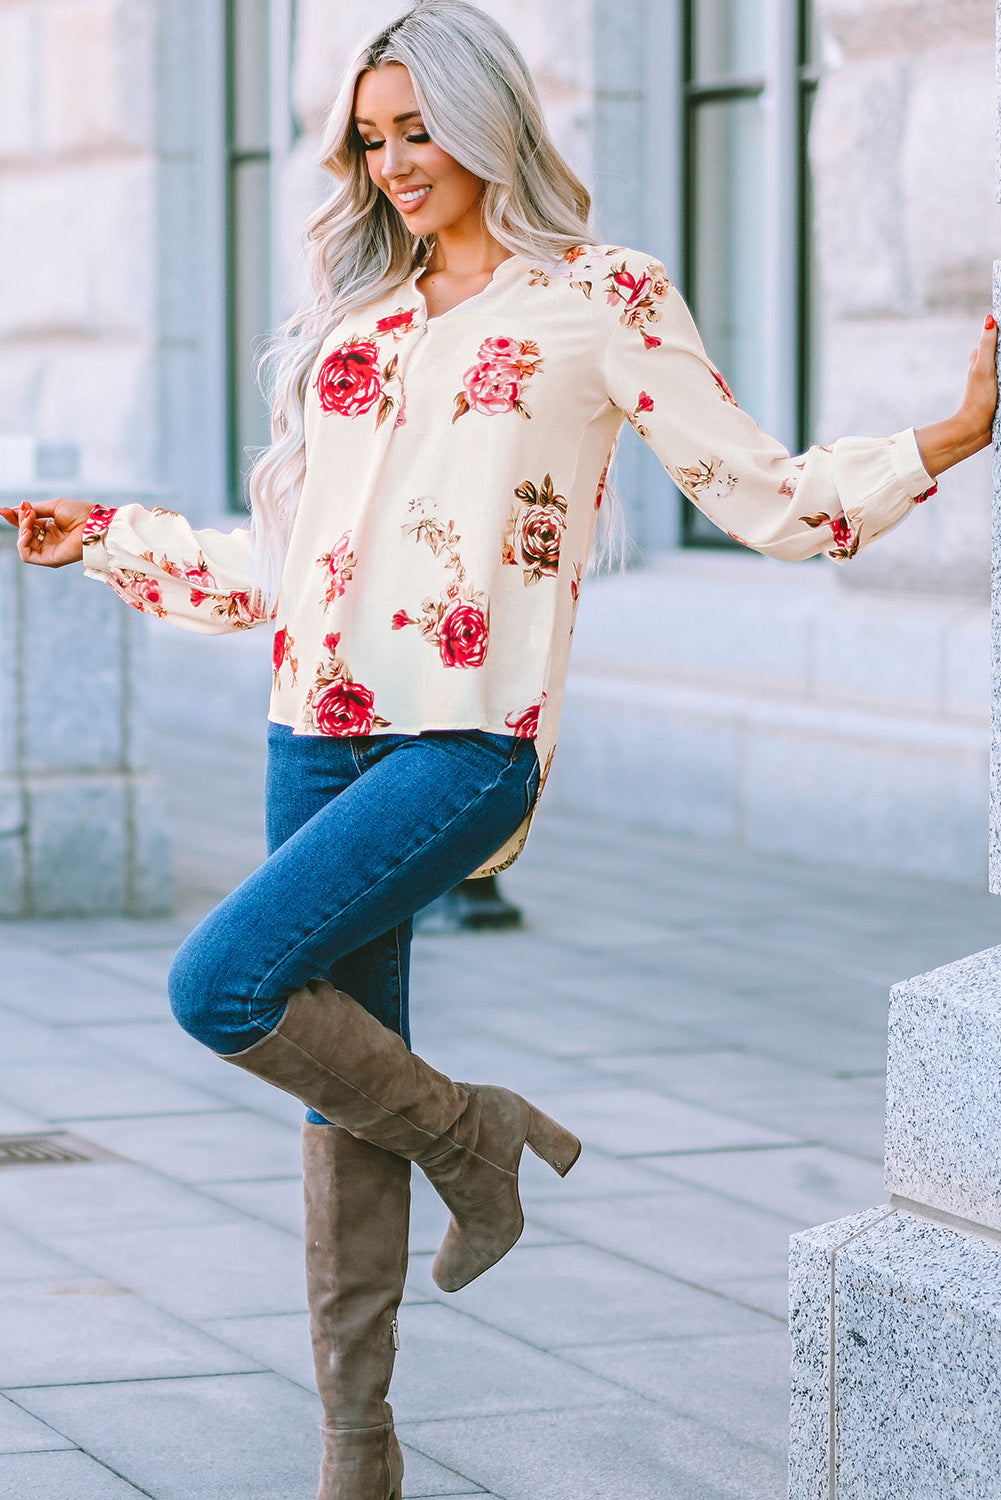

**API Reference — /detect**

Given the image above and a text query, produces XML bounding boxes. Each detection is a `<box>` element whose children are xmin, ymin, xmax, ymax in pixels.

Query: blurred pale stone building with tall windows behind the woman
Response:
<box><xmin>0</xmin><ymin>0</ymin><xmax>998</xmax><ymax>882</ymax></box>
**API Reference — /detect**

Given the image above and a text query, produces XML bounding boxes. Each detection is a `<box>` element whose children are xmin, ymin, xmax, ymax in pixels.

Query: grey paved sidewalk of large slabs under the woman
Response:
<box><xmin>0</xmin><ymin>726</ymin><xmax>1001</xmax><ymax>1500</ymax></box>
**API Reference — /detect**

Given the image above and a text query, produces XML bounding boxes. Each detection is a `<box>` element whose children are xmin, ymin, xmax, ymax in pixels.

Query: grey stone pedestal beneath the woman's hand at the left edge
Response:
<box><xmin>0</xmin><ymin>489</ymin><xmax>171</xmax><ymax>918</ymax></box>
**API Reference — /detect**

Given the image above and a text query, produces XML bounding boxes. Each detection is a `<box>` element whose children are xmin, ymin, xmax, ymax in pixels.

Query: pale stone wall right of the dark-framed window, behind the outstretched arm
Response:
<box><xmin>810</xmin><ymin>0</ymin><xmax>1001</xmax><ymax>597</ymax></box>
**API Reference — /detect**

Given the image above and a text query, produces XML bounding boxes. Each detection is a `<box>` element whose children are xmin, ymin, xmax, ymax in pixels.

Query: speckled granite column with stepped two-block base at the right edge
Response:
<box><xmin>789</xmin><ymin>12</ymin><xmax>1001</xmax><ymax>1500</ymax></box>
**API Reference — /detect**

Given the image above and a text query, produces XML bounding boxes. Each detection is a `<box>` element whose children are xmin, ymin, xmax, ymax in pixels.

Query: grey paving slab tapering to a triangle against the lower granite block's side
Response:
<box><xmin>566</xmin><ymin>1338</ymin><xmax>791</xmax><ymax>1463</ymax></box>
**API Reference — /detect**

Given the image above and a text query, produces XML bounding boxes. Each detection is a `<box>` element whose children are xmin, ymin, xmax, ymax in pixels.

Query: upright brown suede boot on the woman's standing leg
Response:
<box><xmin>302</xmin><ymin>1125</ymin><xmax>410</xmax><ymax>1500</ymax></box>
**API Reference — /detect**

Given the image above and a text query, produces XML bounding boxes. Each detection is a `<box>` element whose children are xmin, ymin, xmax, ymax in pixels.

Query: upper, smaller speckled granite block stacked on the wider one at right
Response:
<box><xmin>884</xmin><ymin>948</ymin><xmax>1001</xmax><ymax>1230</ymax></box>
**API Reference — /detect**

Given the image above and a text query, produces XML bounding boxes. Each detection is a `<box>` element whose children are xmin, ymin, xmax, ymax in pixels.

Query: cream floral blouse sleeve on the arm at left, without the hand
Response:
<box><xmin>84</xmin><ymin>506</ymin><xmax>269</xmax><ymax>635</ymax></box>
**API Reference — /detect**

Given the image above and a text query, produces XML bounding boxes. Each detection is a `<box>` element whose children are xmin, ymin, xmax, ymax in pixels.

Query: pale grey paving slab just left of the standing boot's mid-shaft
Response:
<box><xmin>59</xmin><ymin>1215</ymin><xmax>306</xmax><ymax>1322</ymax></box>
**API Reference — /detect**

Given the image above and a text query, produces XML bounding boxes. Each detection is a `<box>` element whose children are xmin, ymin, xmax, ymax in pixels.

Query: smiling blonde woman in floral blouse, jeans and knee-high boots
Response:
<box><xmin>5</xmin><ymin>0</ymin><xmax>996</xmax><ymax>1500</ymax></box>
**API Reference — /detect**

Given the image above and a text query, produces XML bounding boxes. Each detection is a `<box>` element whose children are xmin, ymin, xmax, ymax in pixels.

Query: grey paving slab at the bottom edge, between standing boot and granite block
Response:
<box><xmin>402</xmin><ymin>1398</ymin><xmax>786</xmax><ymax>1500</ymax></box>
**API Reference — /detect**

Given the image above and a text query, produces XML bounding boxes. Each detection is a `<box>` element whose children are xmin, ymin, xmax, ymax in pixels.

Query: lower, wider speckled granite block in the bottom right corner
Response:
<box><xmin>789</xmin><ymin>1209</ymin><xmax>1001</xmax><ymax>1500</ymax></box>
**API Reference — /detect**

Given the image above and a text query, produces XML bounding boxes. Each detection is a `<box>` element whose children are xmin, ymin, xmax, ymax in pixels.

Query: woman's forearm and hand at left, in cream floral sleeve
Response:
<box><xmin>0</xmin><ymin>500</ymin><xmax>270</xmax><ymax>635</ymax></box>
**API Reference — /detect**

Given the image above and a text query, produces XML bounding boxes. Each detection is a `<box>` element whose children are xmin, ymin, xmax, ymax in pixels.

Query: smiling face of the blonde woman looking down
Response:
<box><xmin>354</xmin><ymin>63</ymin><xmax>483</xmax><ymax>234</ymax></box>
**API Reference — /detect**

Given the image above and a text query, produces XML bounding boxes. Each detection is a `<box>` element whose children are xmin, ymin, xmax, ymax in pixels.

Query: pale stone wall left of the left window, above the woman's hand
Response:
<box><xmin>0</xmin><ymin>0</ymin><xmax>224</xmax><ymax>513</ymax></box>
